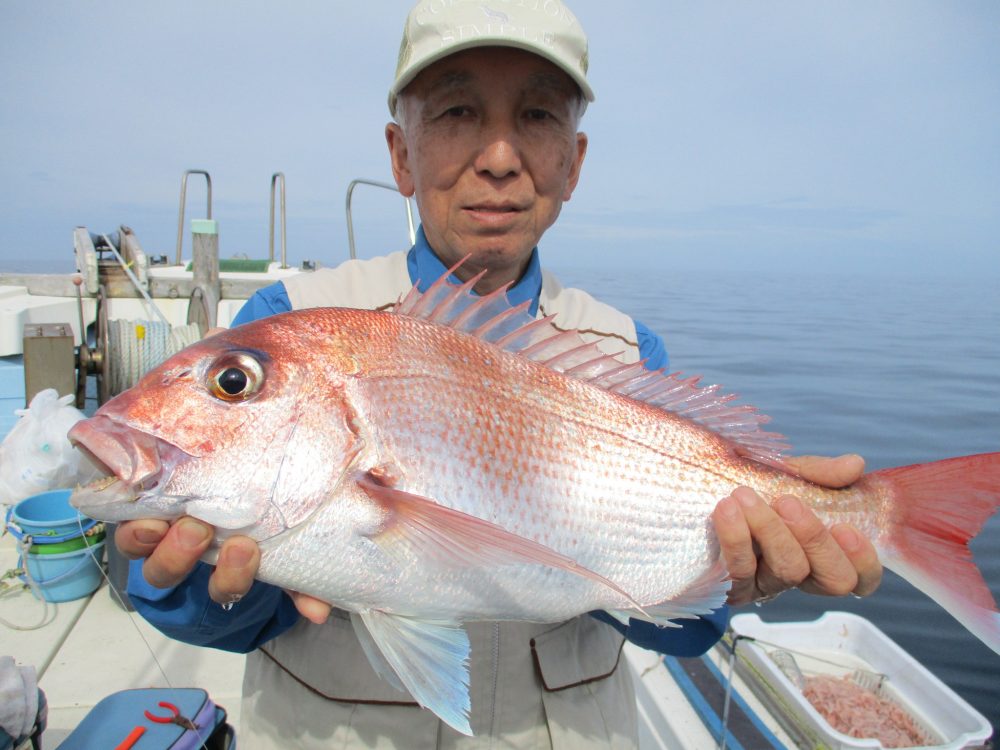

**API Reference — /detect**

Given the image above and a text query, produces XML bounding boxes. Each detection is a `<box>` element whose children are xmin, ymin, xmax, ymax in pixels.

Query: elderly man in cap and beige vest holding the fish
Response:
<box><xmin>117</xmin><ymin>0</ymin><xmax>881</xmax><ymax>748</ymax></box>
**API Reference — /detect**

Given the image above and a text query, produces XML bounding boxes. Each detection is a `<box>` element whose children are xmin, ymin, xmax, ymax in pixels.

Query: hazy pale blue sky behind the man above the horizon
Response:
<box><xmin>0</xmin><ymin>0</ymin><xmax>1000</xmax><ymax>275</ymax></box>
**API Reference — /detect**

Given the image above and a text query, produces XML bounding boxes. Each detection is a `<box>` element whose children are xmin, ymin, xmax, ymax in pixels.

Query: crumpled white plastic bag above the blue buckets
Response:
<box><xmin>0</xmin><ymin>388</ymin><xmax>100</xmax><ymax>505</ymax></box>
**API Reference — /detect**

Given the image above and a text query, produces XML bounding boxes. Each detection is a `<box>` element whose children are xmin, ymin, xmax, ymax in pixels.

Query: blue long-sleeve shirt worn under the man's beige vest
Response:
<box><xmin>128</xmin><ymin>234</ymin><xmax>729</xmax><ymax>656</ymax></box>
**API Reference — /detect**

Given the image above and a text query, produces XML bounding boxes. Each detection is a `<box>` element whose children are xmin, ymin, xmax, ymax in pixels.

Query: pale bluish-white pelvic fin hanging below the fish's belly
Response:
<box><xmin>351</xmin><ymin>610</ymin><xmax>472</xmax><ymax>736</ymax></box>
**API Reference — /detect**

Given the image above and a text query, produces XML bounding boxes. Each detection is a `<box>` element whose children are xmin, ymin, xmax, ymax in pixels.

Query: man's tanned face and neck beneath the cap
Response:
<box><xmin>386</xmin><ymin>47</ymin><xmax>587</xmax><ymax>293</ymax></box>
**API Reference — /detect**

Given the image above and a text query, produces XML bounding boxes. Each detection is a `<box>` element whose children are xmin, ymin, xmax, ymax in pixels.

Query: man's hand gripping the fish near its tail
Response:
<box><xmin>712</xmin><ymin>455</ymin><xmax>882</xmax><ymax>605</ymax></box>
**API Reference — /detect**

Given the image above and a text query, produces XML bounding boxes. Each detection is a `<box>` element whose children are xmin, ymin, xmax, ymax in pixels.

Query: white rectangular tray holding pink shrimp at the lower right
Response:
<box><xmin>730</xmin><ymin>612</ymin><xmax>993</xmax><ymax>750</ymax></box>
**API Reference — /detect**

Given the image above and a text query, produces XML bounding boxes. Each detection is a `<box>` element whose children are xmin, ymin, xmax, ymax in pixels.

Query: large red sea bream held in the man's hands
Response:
<box><xmin>70</xmin><ymin>268</ymin><xmax>1000</xmax><ymax>733</ymax></box>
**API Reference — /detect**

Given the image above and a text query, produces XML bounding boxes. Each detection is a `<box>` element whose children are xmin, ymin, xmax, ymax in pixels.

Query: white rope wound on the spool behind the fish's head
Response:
<box><xmin>108</xmin><ymin>320</ymin><xmax>201</xmax><ymax>396</ymax></box>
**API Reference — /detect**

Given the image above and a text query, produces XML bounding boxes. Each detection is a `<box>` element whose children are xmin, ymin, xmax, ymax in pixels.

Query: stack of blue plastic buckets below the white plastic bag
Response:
<box><xmin>7</xmin><ymin>490</ymin><xmax>104</xmax><ymax>602</ymax></box>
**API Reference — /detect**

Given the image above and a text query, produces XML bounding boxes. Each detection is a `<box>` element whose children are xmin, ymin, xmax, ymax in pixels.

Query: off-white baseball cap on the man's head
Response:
<box><xmin>389</xmin><ymin>0</ymin><xmax>594</xmax><ymax>117</ymax></box>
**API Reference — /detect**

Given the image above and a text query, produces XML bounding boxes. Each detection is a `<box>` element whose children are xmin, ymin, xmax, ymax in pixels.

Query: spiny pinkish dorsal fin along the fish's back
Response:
<box><xmin>393</xmin><ymin>256</ymin><xmax>789</xmax><ymax>470</ymax></box>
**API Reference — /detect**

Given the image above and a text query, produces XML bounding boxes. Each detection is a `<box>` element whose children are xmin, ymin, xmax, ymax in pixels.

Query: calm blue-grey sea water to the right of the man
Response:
<box><xmin>557</xmin><ymin>269</ymin><xmax>1000</xmax><ymax>727</ymax></box>
